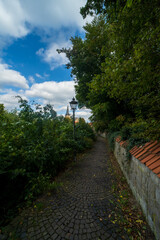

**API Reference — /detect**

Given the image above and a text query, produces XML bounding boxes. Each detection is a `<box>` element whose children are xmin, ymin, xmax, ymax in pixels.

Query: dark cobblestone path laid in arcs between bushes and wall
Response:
<box><xmin>0</xmin><ymin>138</ymin><xmax>154</xmax><ymax>240</ymax></box>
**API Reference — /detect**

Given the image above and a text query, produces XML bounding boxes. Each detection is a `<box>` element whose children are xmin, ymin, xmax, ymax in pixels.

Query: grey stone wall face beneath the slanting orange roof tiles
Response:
<box><xmin>114</xmin><ymin>142</ymin><xmax>160</xmax><ymax>240</ymax></box>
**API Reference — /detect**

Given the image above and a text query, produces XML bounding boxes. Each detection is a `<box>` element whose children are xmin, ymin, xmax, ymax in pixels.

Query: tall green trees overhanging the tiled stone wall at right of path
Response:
<box><xmin>62</xmin><ymin>0</ymin><xmax>160</xmax><ymax>141</ymax></box>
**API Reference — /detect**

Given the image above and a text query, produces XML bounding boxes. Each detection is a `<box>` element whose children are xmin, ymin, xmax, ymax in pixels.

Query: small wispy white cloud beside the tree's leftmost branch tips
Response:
<box><xmin>37</xmin><ymin>41</ymin><xmax>71</xmax><ymax>70</ymax></box>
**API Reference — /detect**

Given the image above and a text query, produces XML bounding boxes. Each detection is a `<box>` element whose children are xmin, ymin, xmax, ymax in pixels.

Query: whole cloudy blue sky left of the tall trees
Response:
<box><xmin>0</xmin><ymin>0</ymin><xmax>91</xmax><ymax>120</ymax></box>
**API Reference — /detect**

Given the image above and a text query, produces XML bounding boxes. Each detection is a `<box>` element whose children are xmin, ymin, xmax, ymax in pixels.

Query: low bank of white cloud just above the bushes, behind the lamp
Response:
<box><xmin>0</xmin><ymin>81</ymin><xmax>91</xmax><ymax>121</ymax></box>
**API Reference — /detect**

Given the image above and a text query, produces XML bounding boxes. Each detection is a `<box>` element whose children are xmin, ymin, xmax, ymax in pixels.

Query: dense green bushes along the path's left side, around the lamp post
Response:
<box><xmin>0</xmin><ymin>97</ymin><xmax>95</xmax><ymax>225</ymax></box>
